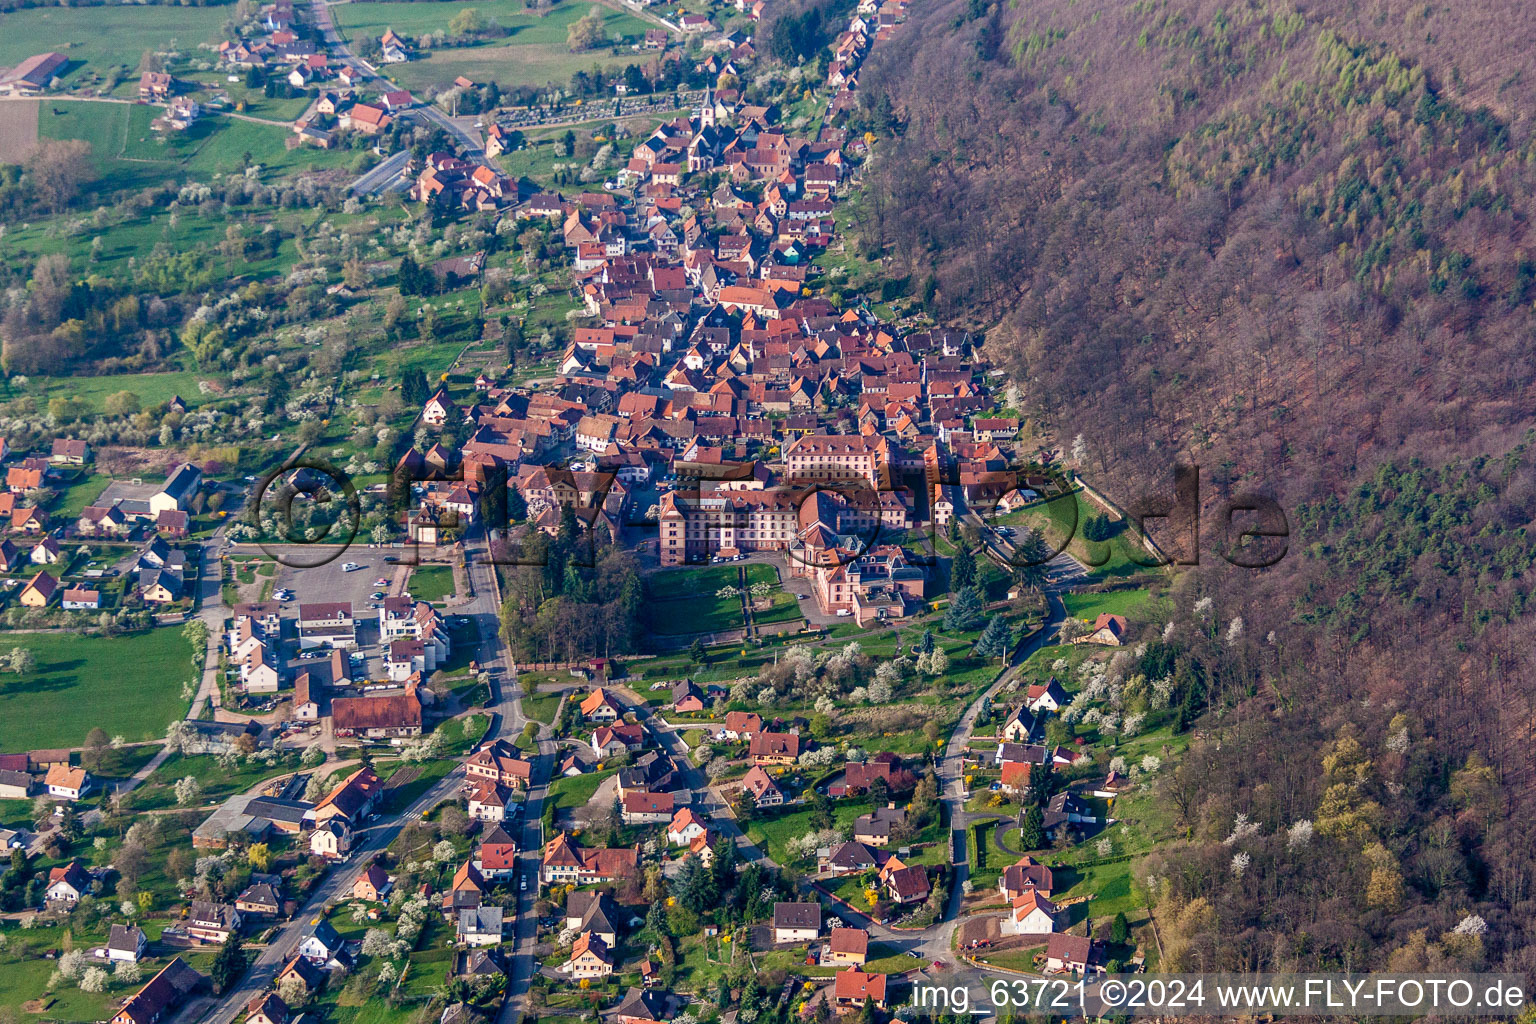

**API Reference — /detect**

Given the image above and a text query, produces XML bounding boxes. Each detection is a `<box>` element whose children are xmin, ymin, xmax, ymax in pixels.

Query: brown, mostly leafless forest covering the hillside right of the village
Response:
<box><xmin>856</xmin><ymin>0</ymin><xmax>1536</xmax><ymax>976</ymax></box>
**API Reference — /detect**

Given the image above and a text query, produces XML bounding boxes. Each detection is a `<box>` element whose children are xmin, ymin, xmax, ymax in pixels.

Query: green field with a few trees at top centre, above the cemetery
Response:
<box><xmin>332</xmin><ymin>0</ymin><xmax>654</xmax><ymax>92</ymax></box>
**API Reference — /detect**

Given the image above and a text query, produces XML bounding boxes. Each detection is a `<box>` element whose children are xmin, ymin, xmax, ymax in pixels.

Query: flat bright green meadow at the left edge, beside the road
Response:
<box><xmin>0</xmin><ymin>626</ymin><xmax>192</xmax><ymax>751</ymax></box>
